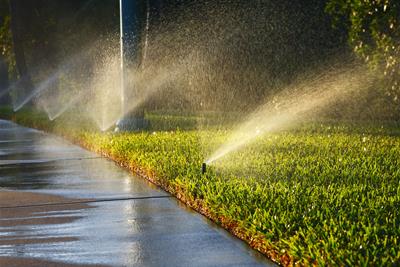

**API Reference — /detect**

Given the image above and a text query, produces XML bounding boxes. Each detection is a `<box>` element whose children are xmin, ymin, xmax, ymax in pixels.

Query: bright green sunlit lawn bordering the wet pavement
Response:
<box><xmin>0</xmin><ymin>106</ymin><xmax>400</xmax><ymax>266</ymax></box>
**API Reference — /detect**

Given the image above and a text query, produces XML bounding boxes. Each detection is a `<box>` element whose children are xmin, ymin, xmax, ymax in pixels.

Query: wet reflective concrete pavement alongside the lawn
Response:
<box><xmin>0</xmin><ymin>120</ymin><xmax>273</xmax><ymax>266</ymax></box>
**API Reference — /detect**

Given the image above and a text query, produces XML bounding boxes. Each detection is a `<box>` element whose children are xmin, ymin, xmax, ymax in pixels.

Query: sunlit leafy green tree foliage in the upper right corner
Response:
<box><xmin>326</xmin><ymin>0</ymin><xmax>400</xmax><ymax>101</ymax></box>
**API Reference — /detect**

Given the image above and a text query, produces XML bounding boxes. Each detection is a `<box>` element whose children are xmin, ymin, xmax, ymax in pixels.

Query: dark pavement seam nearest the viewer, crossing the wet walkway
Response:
<box><xmin>0</xmin><ymin>195</ymin><xmax>173</xmax><ymax>209</ymax></box>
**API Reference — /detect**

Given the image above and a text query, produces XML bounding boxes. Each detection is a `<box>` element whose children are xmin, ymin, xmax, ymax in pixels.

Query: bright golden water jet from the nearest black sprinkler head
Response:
<box><xmin>206</xmin><ymin>67</ymin><xmax>373</xmax><ymax>164</ymax></box>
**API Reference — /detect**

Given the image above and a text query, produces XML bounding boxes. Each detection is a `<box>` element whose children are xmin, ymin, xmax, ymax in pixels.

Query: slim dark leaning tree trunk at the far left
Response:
<box><xmin>10</xmin><ymin>0</ymin><xmax>34</xmax><ymax>95</ymax></box>
